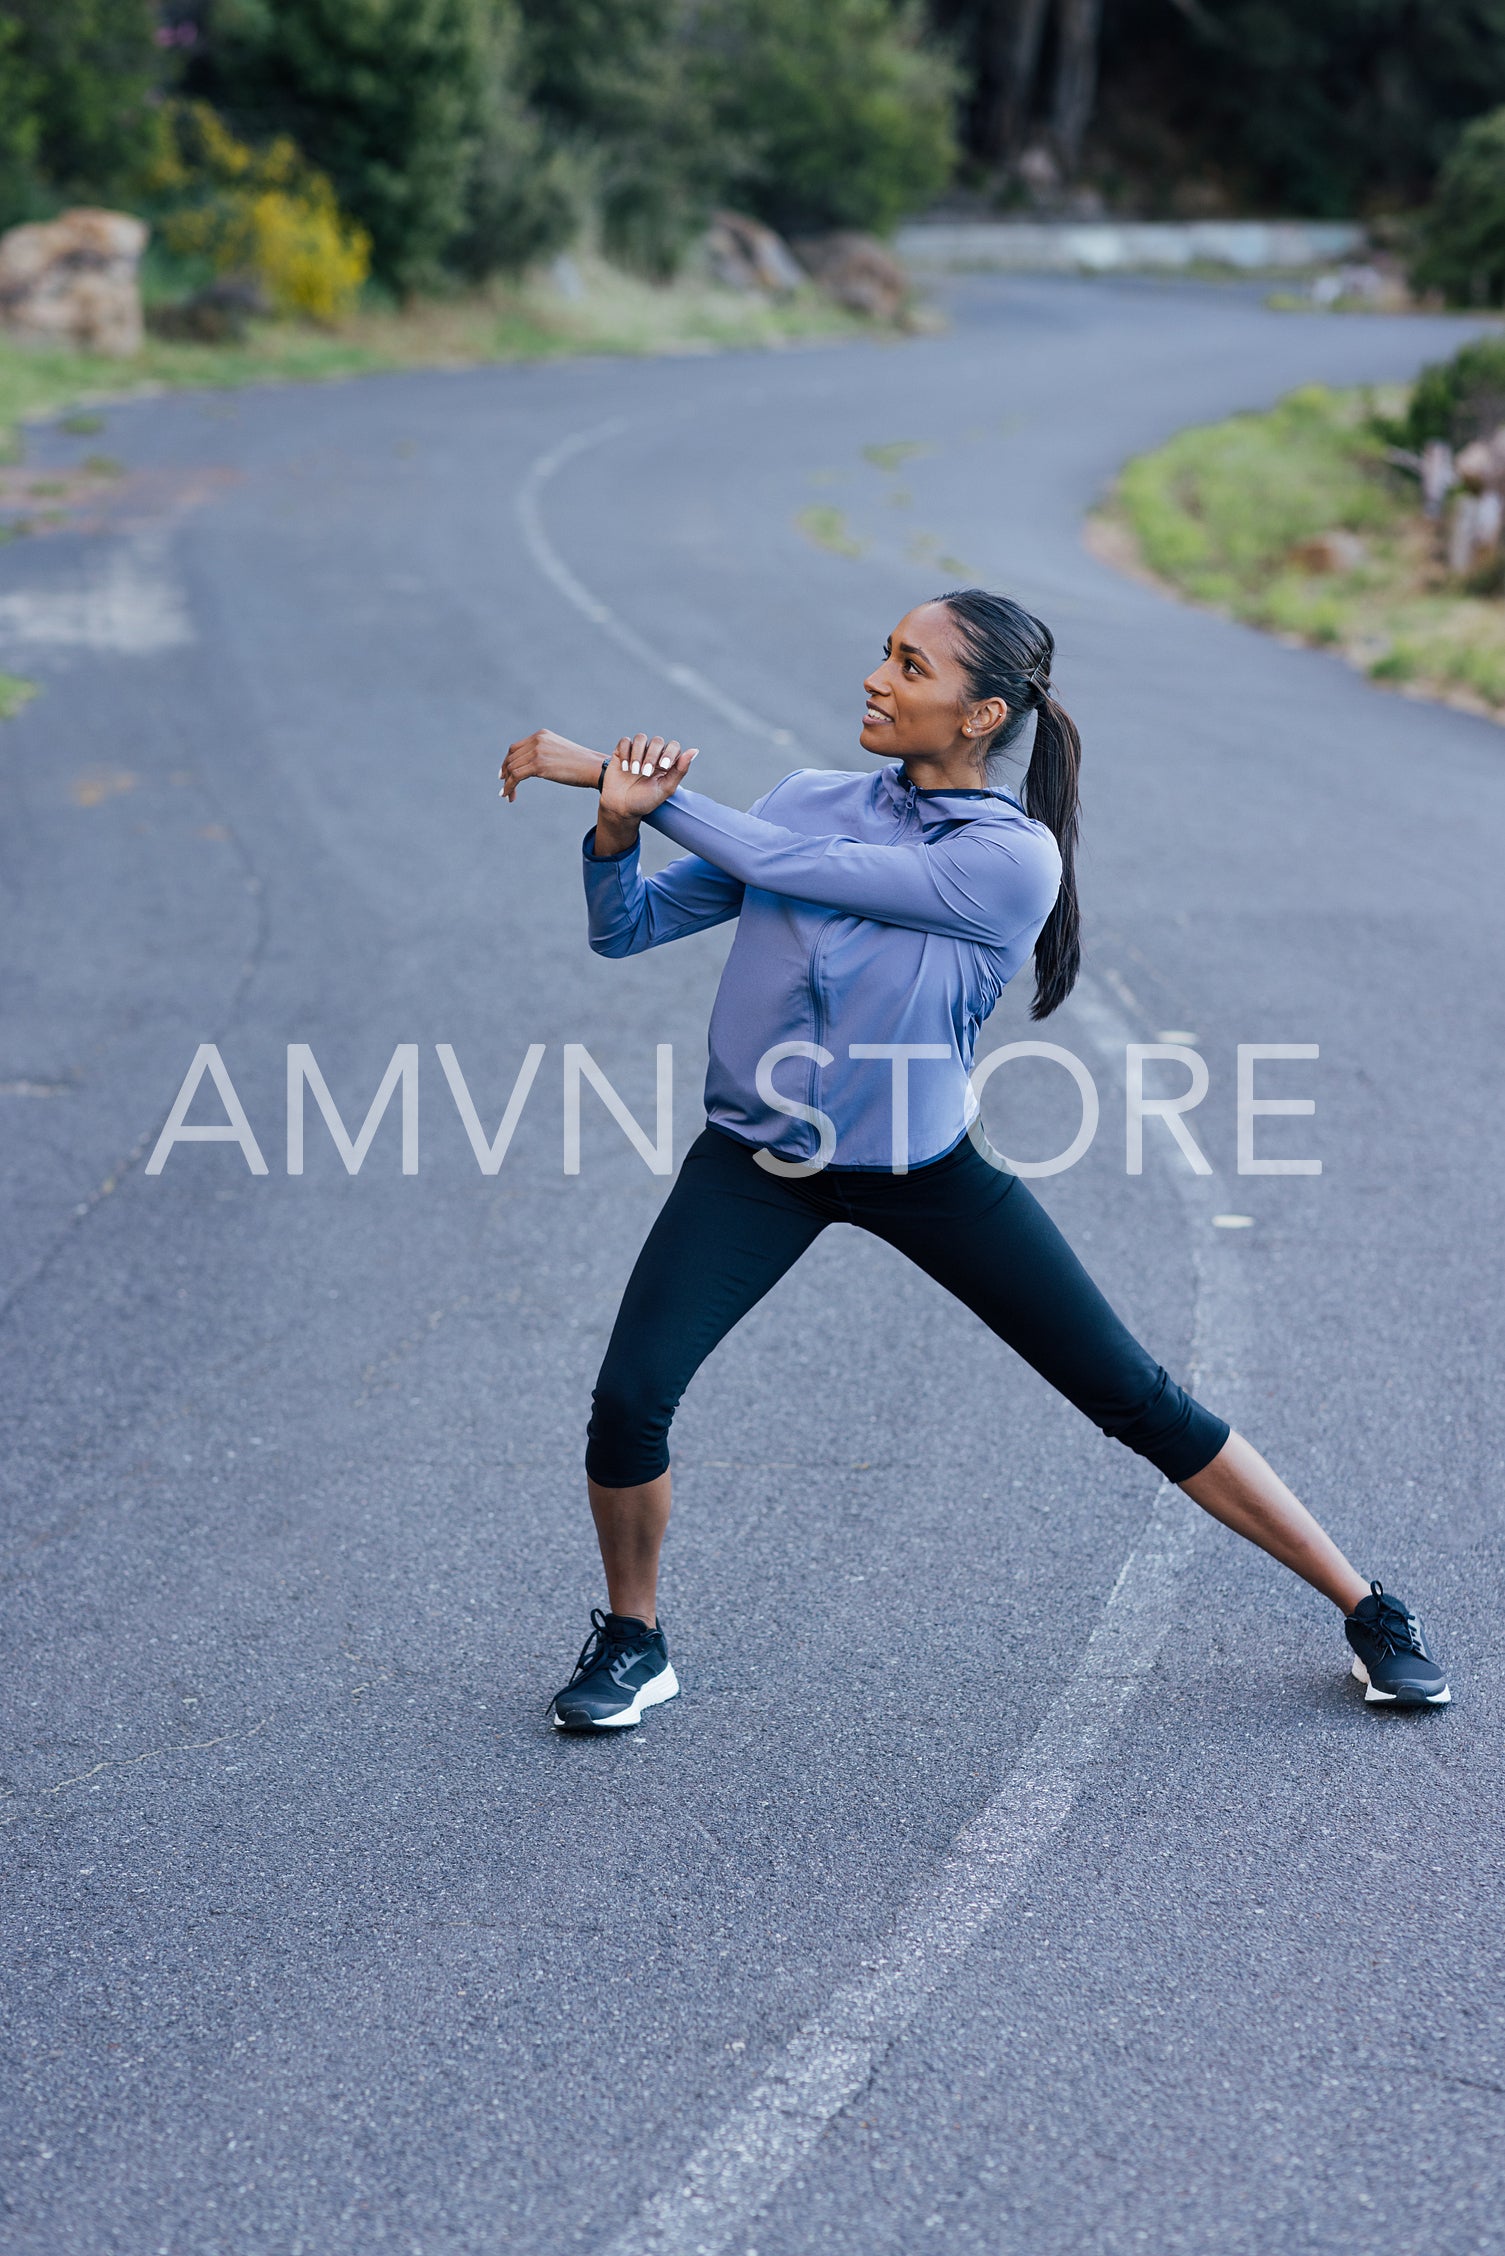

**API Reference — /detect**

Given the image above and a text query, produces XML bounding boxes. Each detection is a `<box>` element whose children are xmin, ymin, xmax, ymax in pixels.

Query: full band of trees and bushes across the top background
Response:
<box><xmin>0</xmin><ymin>0</ymin><xmax>1505</xmax><ymax>302</ymax></box>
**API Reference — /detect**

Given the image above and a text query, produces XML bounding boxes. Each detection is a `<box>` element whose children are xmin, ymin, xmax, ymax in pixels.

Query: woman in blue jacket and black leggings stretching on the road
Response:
<box><xmin>501</xmin><ymin>589</ymin><xmax>1451</xmax><ymax>1730</ymax></box>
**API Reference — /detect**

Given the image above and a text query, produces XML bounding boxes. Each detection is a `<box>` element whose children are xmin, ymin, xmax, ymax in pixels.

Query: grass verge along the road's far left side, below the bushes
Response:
<box><xmin>0</xmin><ymin>257</ymin><xmax>896</xmax><ymax>460</ymax></box>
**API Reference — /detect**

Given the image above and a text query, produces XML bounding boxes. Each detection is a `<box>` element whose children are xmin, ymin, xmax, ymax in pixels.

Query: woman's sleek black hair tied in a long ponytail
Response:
<box><xmin>934</xmin><ymin>587</ymin><xmax>1081</xmax><ymax>1017</ymax></box>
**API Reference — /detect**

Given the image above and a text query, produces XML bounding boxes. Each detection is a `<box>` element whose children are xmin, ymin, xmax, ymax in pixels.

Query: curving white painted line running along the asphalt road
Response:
<box><xmin>519</xmin><ymin>420</ymin><xmax>1246</xmax><ymax>2256</ymax></box>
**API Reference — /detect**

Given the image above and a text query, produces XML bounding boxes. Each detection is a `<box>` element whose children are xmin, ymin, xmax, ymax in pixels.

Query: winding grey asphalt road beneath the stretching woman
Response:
<box><xmin>0</xmin><ymin>280</ymin><xmax>1505</xmax><ymax>2256</ymax></box>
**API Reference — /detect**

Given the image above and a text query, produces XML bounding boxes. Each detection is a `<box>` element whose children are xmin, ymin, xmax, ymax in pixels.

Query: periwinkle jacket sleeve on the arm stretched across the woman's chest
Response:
<box><xmin>648</xmin><ymin>785</ymin><xmax>1060</xmax><ymax>948</ymax></box>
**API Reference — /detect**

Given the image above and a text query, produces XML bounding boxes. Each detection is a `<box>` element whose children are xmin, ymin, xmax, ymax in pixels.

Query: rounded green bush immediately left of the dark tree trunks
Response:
<box><xmin>706</xmin><ymin>0</ymin><xmax>957</xmax><ymax>235</ymax></box>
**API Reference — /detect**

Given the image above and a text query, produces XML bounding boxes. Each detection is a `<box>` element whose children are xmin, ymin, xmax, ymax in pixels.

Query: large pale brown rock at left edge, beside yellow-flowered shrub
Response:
<box><xmin>0</xmin><ymin>208</ymin><xmax>151</xmax><ymax>356</ymax></box>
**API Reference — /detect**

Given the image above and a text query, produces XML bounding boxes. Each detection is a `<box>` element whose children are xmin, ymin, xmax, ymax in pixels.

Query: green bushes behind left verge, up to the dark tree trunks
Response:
<box><xmin>0</xmin><ymin>0</ymin><xmax>954</xmax><ymax>291</ymax></box>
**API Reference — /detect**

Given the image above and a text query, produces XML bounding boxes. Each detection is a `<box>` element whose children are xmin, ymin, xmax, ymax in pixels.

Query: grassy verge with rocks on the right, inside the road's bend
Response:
<box><xmin>1090</xmin><ymin>386</ymin><xmax>1505</xmax><ymax>720</ymax></box>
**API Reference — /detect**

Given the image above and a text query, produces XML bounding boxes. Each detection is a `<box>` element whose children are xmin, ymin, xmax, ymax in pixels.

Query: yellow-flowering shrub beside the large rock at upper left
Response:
<box><xmin>147</xmin><ymin>102</ymin><xmax>370</xmax><ymax>323</ymax></box>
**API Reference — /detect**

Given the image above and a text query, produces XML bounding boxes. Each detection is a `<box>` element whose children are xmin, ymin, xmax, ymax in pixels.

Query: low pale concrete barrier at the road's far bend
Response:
<box><xmin>894</xmin><ymin>219</ymin><xmax>1365</xmax><ymax>273</ymax></box>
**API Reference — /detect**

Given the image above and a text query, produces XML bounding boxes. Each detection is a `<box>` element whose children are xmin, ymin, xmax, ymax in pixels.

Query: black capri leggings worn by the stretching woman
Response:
<box><xmin>584</xmin><ymin>1128</ymin><xmax>1230</xmax><ymax>1489</ymax></box>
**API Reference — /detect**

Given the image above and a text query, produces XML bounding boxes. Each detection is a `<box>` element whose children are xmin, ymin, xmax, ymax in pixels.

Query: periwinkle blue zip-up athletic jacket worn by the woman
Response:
<box><xmin>584</xmin><ymin>765</ymin><xmax>1060</xmax><ymax>1171</ymax></box>
